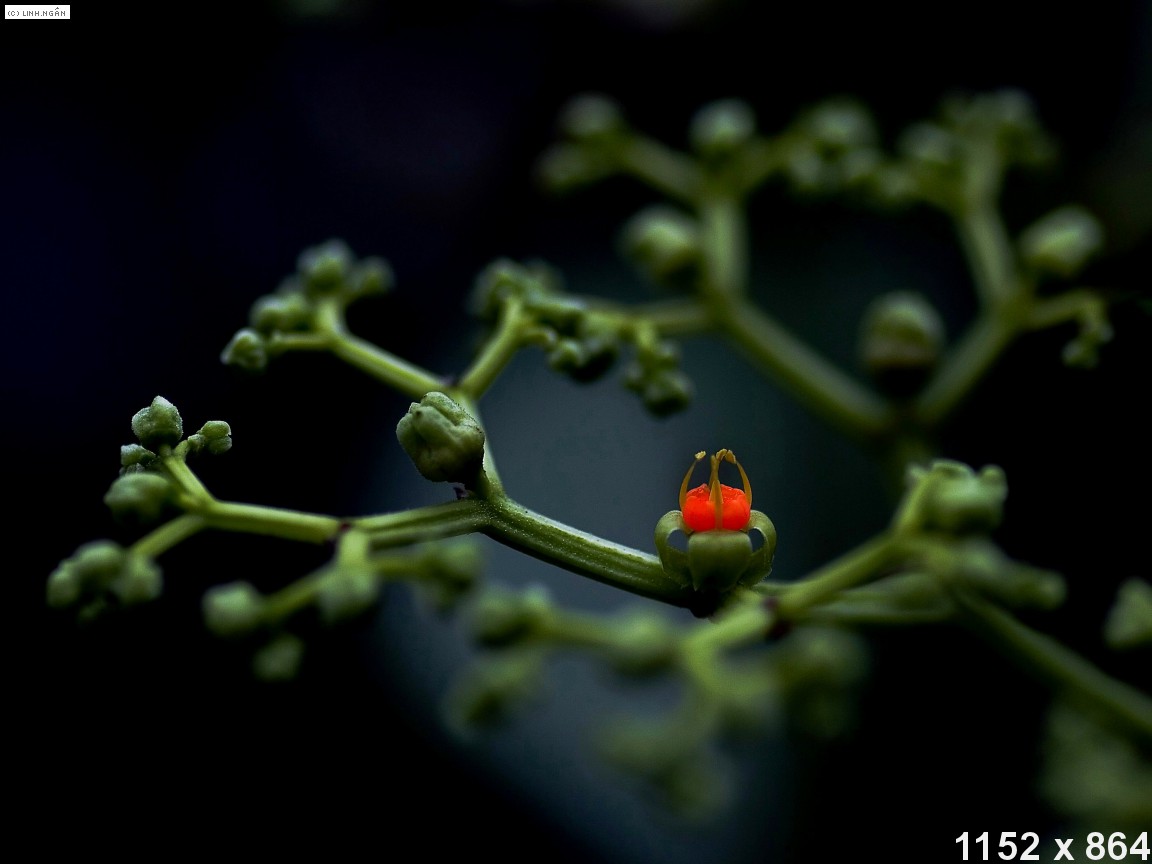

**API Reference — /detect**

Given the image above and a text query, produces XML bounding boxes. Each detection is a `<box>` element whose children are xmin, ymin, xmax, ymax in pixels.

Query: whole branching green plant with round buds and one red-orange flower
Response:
<box><xmin>47</xmin><ymin>91</ymin><xmax>1152</xmax><ymax>847</ymax></box>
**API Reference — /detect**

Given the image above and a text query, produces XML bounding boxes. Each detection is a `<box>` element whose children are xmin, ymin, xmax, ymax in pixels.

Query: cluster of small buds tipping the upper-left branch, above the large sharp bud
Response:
<box><xmin>220</xmin><ymin>240</ymin><xmax>393</xmax><ymax>372</ymax></box>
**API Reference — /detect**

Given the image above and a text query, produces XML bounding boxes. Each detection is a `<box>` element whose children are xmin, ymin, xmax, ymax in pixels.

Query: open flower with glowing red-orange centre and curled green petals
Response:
<box><xmin>655</xmin><ymin>450</ymin><xmax>776</xmax><ymax>593</ymax></box>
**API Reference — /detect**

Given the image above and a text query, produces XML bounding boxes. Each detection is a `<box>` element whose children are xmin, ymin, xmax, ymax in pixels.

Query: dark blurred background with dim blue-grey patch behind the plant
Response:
<box><xmin>0</xmin><ymin>0</ymin><xmax>1152</xmax><ymax>863</ymax></box>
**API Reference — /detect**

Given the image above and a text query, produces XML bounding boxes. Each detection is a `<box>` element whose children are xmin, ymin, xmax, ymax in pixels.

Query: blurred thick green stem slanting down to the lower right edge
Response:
<box><xmin>953</xmin><ymin>588</ymin><xmax>1152</xmax><ymax>743</ymax></box>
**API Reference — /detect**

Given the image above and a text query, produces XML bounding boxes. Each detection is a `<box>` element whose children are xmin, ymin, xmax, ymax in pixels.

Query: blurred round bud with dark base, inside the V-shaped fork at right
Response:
<box><xmin>861</xmin><ymin>291</ymin><xmax>943</xmax><ymax>399</ymax></box>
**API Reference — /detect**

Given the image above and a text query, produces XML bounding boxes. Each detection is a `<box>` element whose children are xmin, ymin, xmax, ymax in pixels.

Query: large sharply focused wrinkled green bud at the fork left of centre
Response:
<box><xmin>396</xmin><ymin>391</ymin><xmax>484</xmax><ymax>487</ymax></box>
